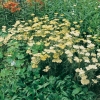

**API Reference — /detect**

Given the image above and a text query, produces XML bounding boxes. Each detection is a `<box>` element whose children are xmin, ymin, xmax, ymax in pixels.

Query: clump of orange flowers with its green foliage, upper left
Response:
<box><xmin>0</xmin><ymin>0</ymin><xmax>44</xmax><ymax>28</ymax></box>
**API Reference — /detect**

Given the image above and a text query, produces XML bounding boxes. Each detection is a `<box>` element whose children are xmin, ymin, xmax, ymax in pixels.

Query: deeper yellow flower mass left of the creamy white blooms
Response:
<box><xmin>2</xmin><ymin>14</ymin><xmax>77</xmax><ymax>68</ymax></box>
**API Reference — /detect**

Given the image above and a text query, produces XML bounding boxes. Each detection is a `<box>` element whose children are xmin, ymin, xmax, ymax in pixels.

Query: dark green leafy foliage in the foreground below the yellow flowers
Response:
<box><xmin>0</xmin><ymin>66</ymin><xmax>95</xmax><ymax>100</ymax></box>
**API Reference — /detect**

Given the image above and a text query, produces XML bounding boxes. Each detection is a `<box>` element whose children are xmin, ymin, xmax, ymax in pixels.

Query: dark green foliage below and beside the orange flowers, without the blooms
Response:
<box><xmin>0</xmin><ymin>0</ymin><xmax>39</xmax><ymax>28</ymax></box>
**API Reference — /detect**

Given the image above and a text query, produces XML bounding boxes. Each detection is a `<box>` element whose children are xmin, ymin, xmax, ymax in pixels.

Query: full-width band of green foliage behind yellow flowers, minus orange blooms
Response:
<box><xmin>0</xmin><ymin>0</ymin><xmax>100</xmax><ymax>34</ymax></box>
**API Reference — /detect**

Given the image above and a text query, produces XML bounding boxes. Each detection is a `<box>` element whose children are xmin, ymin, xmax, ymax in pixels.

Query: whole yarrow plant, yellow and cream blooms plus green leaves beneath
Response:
<box><xmin>0</xmin><ymin>13</ymin><xmax>100</xmax><ymax>85</ymax></box>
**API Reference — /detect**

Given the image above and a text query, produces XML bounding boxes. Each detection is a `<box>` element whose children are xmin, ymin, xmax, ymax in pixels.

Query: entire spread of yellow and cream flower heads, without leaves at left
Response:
<box><xmin>0</xmin><ymin>13</ymin><xmax>100</xmax><ymax>85</ymax></box>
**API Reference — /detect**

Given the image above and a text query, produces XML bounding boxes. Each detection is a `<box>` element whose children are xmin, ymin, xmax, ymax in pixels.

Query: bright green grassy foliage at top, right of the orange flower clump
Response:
<box><xmin>45</xmin><ymin>0</ymin><xmax>100</xmax><ymax>34</ymax></box>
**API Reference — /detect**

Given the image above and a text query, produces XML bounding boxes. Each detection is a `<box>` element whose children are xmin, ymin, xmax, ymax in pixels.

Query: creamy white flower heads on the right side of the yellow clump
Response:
<box><xmin>73</xmin><ymin>35</ymin><xmax>100</xmax><ymax>85</ymax></box>
